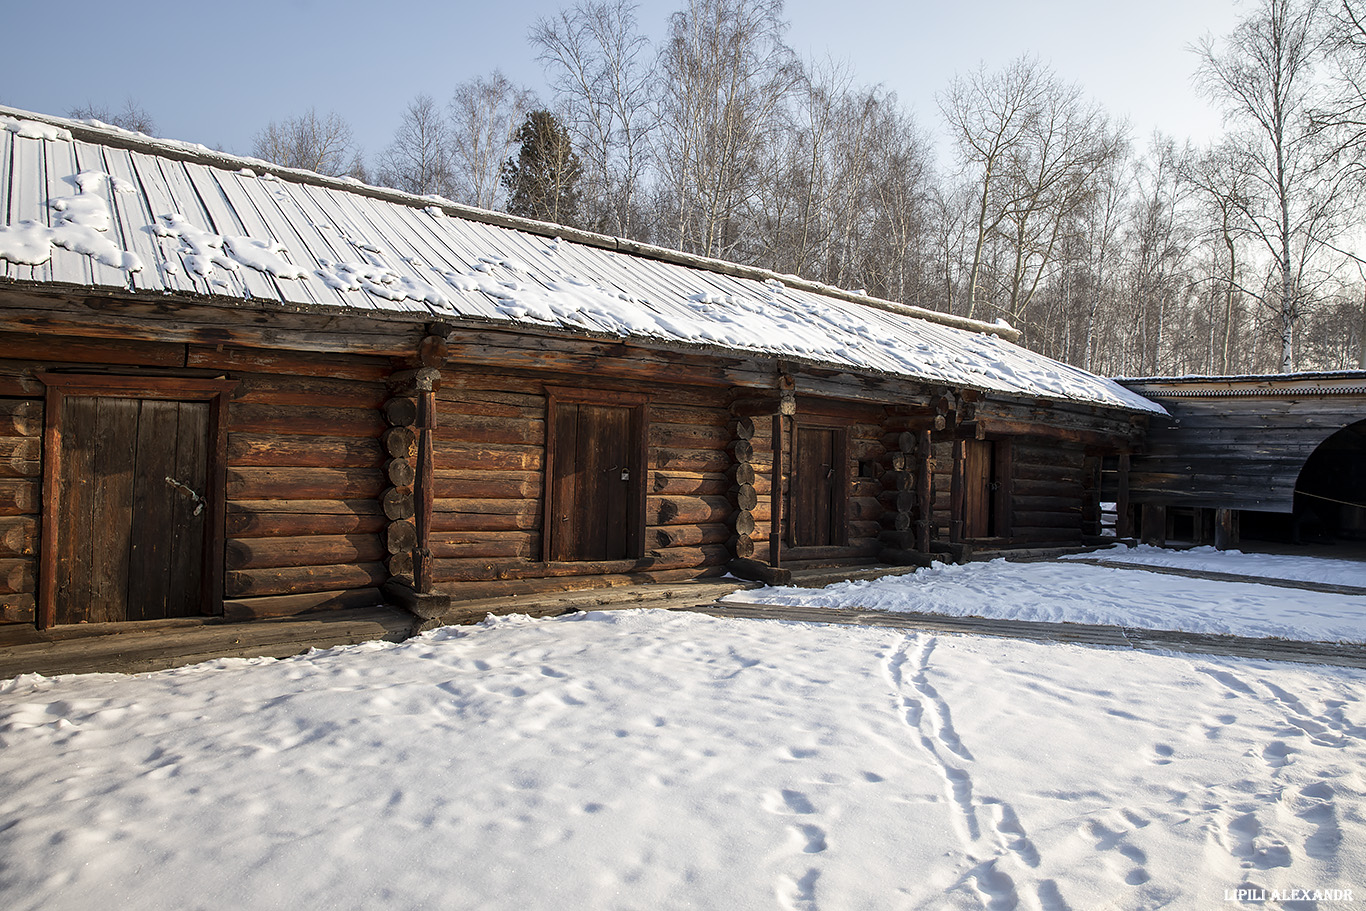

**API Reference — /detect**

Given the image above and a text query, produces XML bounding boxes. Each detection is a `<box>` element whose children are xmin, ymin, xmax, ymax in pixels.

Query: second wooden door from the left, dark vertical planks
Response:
<box><xmin>548</xmin><ymin>402</ymin><xmax>633</xmax><ymax>560</ymax></box>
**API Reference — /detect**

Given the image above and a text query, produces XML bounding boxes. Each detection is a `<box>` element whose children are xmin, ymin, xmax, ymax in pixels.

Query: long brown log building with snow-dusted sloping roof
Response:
<box><xmin>0</xmin><ymin>108</ymin><xmax>1161</xmax><ymax>630</ymax></box>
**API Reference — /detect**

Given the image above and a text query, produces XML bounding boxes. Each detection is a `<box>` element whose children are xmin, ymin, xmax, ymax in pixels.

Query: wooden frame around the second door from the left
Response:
<box><xmin>541</xmin><ymin>385</ymin><xmax>650</xmax><ymax>563</ymax></box>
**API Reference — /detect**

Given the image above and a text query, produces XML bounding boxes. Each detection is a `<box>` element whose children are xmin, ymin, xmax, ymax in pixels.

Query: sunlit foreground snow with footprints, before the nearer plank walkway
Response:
<box><xmin>0</xmin><ymin>564</ymin><xmax>1366</xmax><ymax>911</ymax></box>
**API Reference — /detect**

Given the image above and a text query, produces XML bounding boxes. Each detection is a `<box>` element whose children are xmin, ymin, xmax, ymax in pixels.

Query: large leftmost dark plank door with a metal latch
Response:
<box><xmin>55</xmin><ymin>395</ymin><xmax>209</xmax><ymax>623</ymax></box>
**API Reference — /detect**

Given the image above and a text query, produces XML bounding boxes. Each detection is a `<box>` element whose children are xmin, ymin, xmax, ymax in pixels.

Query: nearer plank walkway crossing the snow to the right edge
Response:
<box><xmin>671</xmin><ymin>601</ymin><xmax>1366</xmax><ymax>668</ymax></box>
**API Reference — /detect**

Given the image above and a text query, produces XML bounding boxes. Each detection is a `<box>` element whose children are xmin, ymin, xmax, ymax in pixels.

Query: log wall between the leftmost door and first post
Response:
<box><xmin>215</xmin><ymin>347</ymin><xmax>392</xmax><ymax>619</ymax></box>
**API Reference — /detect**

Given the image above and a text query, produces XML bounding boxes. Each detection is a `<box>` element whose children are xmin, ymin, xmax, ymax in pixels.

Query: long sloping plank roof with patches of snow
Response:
<box><xmin>0</xmin><ymin>107</ymin><xmax>1162</xmax><ymax>414</ymax></box>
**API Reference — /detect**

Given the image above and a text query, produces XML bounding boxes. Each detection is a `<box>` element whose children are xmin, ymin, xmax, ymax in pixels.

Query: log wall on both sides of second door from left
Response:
<box><xmin>430</xmin><ymin>365</ymin><xmax>735</xmax><ymax>597</ymax></box>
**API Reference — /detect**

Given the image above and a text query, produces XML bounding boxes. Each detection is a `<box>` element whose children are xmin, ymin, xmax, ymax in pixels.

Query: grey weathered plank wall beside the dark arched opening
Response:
<box><xmin>1105</xmin><ymin>374</ymin><xmax>1366</xmax><ymax>512</ymax></box>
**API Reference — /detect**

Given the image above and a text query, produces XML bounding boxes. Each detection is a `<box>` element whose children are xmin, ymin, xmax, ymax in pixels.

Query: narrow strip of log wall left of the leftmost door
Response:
<box><xmin>0</xmin><ymin>388</ymin><xmax>44</xmax><ymax>623</ymax></box>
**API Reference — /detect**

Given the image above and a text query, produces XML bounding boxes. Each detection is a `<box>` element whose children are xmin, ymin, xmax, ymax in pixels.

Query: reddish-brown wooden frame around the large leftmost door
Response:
<box><xmin>36</xmin><ymin>372</ymin><xmax>238</xmax><ymax>630</ymax></box>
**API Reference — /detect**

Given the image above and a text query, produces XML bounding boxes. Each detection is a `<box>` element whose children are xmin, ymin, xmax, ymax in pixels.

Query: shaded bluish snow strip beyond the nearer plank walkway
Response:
<box><xmin>728</xmin><ymin>559</ymin><xmax>1366</xmax><ymax>642</ymax></box>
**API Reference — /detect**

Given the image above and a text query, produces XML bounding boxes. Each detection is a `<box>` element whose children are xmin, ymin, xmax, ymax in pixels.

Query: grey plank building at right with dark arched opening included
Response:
<box><xmin>1123</xmin><ymin>372</ymin><xmax>1366</xmax><ymax>546</ymax></box>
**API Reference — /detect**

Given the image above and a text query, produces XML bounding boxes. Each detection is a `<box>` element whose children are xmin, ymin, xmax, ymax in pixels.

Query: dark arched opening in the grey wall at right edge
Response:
<box><xmin>1294</xmin><ymin>421</ymin><xmax>1366</xmax><ymax>544</ymax></box>
